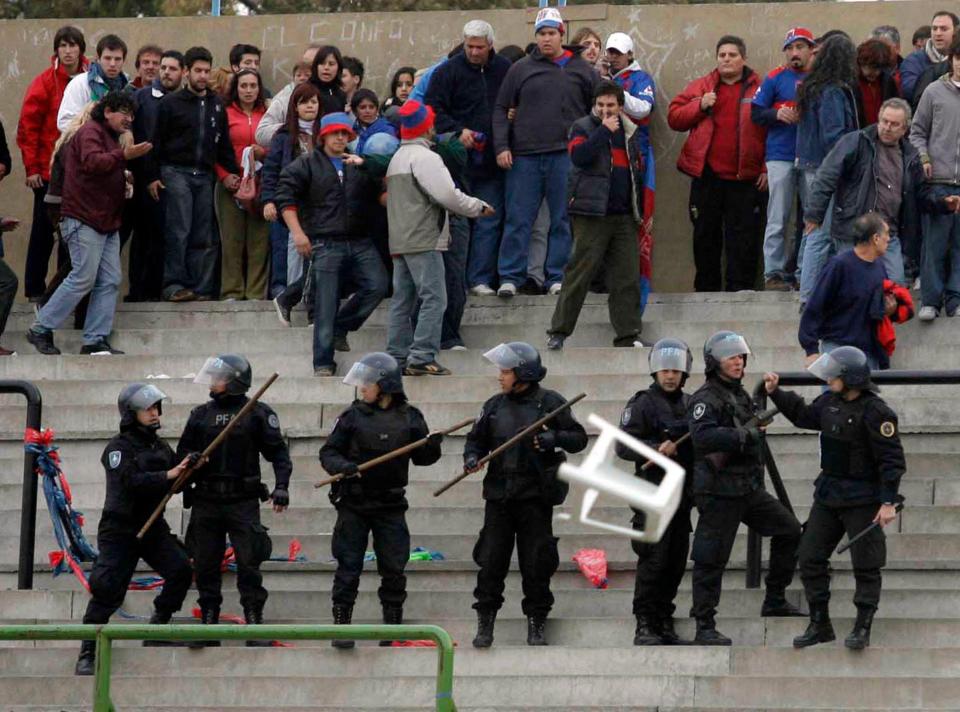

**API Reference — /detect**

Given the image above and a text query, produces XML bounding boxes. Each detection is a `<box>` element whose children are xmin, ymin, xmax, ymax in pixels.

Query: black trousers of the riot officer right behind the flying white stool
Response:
<box><xmin>631</xmin><ymin>495</ymin><xmax>693</xmax><ymax>620</ymax></box>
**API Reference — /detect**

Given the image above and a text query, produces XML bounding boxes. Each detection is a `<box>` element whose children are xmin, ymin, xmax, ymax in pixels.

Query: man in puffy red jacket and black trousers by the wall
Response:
<box><xmin>667</xmin><ymin>35</ymin><xmax>767</xmax><ymax>292</ymax></box>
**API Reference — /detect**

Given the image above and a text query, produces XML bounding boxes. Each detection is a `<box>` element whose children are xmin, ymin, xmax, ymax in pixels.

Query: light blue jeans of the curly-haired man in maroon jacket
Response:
<box><xmin>31</xmin><ymin>220</ymin><xmax>121</xmax><ymax>344</ymax></box>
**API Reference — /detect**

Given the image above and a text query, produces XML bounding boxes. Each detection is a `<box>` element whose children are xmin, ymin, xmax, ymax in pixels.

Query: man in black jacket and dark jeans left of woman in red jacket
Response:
<box><xmin>147</xmin><ymin>47</ymin><xmax>240</xmax><ymax>302</ymax></box>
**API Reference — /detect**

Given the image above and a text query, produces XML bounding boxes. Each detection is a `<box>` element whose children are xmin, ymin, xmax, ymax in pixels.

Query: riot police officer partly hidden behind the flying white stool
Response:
<box><xmin>617</xmin><ymin>339</ymin><xmax>693</xmax><ymax>645</ymax></box>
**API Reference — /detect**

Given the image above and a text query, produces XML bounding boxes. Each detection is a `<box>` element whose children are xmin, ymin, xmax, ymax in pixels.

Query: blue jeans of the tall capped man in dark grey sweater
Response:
<box><xmin>498</xmin><ymin>151</ymin><xmax>571</xmax><ymax>287</ymax></box>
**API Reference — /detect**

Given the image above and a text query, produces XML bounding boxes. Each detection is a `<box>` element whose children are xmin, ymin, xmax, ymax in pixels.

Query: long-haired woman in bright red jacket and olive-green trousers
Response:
<box><xmin>215</xmin><ymin>69</ymin><xmax>270</xmax><ymax>300</ymax></box>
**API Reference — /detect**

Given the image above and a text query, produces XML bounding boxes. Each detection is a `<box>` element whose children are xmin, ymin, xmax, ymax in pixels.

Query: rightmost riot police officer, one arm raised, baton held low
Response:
<box><xmin>764</xmin><ymin>346</ymin><xmax>906</xmax><ymax>650</ymax></box>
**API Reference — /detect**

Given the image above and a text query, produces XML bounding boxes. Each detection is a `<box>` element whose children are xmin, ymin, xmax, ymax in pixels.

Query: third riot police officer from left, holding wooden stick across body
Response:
<box><xmin>320</xmin><ymin>353</ymin><xmax>443</xmax><ymax>648</ymax></box>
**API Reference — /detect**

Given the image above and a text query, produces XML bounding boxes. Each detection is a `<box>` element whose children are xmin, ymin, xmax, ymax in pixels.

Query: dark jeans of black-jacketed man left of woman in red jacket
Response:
<box><xmin>160</xmin><ymin>166</ymin><xmax>220</xmax><ymax>297</ymax></box>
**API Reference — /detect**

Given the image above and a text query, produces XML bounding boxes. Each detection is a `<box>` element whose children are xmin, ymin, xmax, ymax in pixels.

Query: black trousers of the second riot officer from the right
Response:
<box><xmin>690</xmin><ymin>490</ymin><xmax>800</xmax><ymax>618</ymax></box>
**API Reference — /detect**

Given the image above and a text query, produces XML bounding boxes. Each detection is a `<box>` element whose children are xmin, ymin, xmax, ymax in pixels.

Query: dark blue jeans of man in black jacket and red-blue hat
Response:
<box><xmin>311</xmin><ymin>239</ymin><xmax>387</xmax><ymax>368</ymax></box>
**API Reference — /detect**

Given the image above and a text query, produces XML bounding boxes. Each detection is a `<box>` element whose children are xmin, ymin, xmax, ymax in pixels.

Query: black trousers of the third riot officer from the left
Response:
<box><xmin>330</xmin><ymin>503</ymin><xmax>410</xmax><ymax>608</ymax></box>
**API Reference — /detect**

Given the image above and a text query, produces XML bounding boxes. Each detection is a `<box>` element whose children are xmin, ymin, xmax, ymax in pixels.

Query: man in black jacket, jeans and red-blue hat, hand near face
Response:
<box><xmin>274</xmin><ymin>112</ymin><xmax>388</xmax><ymax>376</ymax></box>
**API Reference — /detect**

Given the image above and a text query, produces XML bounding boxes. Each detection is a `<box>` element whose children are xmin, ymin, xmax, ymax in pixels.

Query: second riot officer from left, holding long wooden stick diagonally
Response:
<box><xmin>177</xmin><ymin>354</ymin><xmax>292</xmax><ymax>645</ymax></box>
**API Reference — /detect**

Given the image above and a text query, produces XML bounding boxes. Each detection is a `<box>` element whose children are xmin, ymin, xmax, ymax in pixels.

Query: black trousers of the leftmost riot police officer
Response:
<box><xmin>83</xmin><ymin>514</ymin><xmax>193</xmax><ymax>623</ymax></box>
